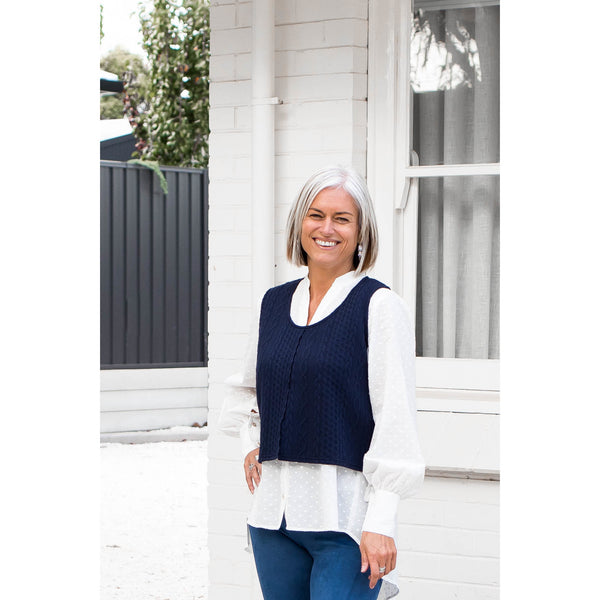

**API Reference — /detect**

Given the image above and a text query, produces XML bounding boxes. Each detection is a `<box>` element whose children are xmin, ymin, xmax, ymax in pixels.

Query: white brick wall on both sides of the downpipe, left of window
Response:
<box><xmin>208</xmin><ymin>0</ymin><xmax>368</xmax><ymax>600</ymax></box>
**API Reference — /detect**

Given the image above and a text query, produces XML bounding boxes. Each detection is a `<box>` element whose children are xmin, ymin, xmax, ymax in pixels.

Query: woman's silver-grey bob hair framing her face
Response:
<box><xmin>286</xmin><ymin>166</ymin><xmax>378</xmax><ymax>273</ymax></box>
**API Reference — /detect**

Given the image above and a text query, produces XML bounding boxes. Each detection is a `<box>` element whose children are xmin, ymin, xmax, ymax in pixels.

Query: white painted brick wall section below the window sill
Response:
<box><xmin>397</xmin><ymin>477</ymin><xmax>500</xmax><ymax>600</ymax></box>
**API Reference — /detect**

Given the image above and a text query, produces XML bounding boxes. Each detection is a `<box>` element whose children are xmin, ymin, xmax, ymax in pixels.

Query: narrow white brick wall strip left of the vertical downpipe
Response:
<box><xmin>208</xmin><ymin>0</ymin><xmax>262</xmax><ymax>600</ymax></box>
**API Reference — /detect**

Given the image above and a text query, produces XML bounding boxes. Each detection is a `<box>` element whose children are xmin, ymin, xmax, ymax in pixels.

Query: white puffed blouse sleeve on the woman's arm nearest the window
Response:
<box><xmin>363</xmin><ymin>289</ymin><xmax>425</xmax><ymax>537</ymax></box>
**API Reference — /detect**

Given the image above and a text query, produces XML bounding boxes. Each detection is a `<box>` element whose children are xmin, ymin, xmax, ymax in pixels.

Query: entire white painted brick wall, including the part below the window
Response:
<box><xmin>208</xmin><ymin>0</ymin><xmax>498</xmax><ymax>600</ymax></box>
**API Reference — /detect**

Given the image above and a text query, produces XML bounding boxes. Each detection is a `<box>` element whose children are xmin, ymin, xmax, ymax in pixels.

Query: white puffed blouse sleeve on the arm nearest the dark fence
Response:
<box><xmin>217</xmin><ymin>302</ymin><xmax>260</xmax><ymax>457</ymax></box>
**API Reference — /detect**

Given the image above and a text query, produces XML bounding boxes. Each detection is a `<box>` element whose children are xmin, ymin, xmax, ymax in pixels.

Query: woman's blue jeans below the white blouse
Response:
<box><xmin>248</xmin><ymin>517</ymin><xmax>381</xmax><ymax>600</ymax></box>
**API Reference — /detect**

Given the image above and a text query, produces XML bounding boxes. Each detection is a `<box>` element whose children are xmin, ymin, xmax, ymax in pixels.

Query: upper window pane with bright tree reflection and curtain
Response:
<box><xmin>410</xmin><ymin>2</ymin><xmax>500</xmax><ymax>165</ymax></box>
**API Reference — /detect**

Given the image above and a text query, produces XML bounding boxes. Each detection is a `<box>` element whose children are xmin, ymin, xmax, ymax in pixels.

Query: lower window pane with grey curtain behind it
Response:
<box><xmin>416</xmin><ymin>175</ymin><xmax>500</xmax><ymax>359</ymax></box>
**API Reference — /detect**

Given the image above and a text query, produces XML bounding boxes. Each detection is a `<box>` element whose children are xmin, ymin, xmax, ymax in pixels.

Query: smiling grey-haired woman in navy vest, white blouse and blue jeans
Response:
<box><xmin>219</xmin><ymin>167</ymin><xmax>424</xmax><ymax>600</ymax></box>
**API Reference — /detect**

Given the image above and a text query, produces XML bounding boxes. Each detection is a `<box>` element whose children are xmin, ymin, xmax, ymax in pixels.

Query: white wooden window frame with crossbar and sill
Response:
<box><xmin>367</xmin><ymin>0</ymin><xmax>500</xmax><ymax>404</ymax></box>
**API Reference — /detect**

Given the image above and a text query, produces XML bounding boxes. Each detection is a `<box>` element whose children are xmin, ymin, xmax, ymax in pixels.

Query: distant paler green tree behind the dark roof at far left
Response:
<box><xmin>100</xmin><ymin>46</ymin><xmax>148</xmax><ymax>119</ymax></box>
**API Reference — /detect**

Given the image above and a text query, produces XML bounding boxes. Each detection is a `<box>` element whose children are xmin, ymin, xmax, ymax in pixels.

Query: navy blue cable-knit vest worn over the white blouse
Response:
<box><xmin>256</xmin><ymin>277</ymin><xmax>387</xmax><ymax>471</ymax></box>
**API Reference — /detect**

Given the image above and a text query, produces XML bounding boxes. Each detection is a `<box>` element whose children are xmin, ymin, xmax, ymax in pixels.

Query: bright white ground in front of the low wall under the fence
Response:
<box><xmin>100</xmin><ymin>428</ymin><xmax>208</xmax><ymax>600</ymax></box>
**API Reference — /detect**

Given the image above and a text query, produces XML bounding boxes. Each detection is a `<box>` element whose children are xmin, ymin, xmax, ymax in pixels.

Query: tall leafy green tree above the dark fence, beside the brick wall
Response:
<box><xmin>125</xmin><ymin>0</ymin><xmax>210</xmax><ymax>168</ymax></box>
